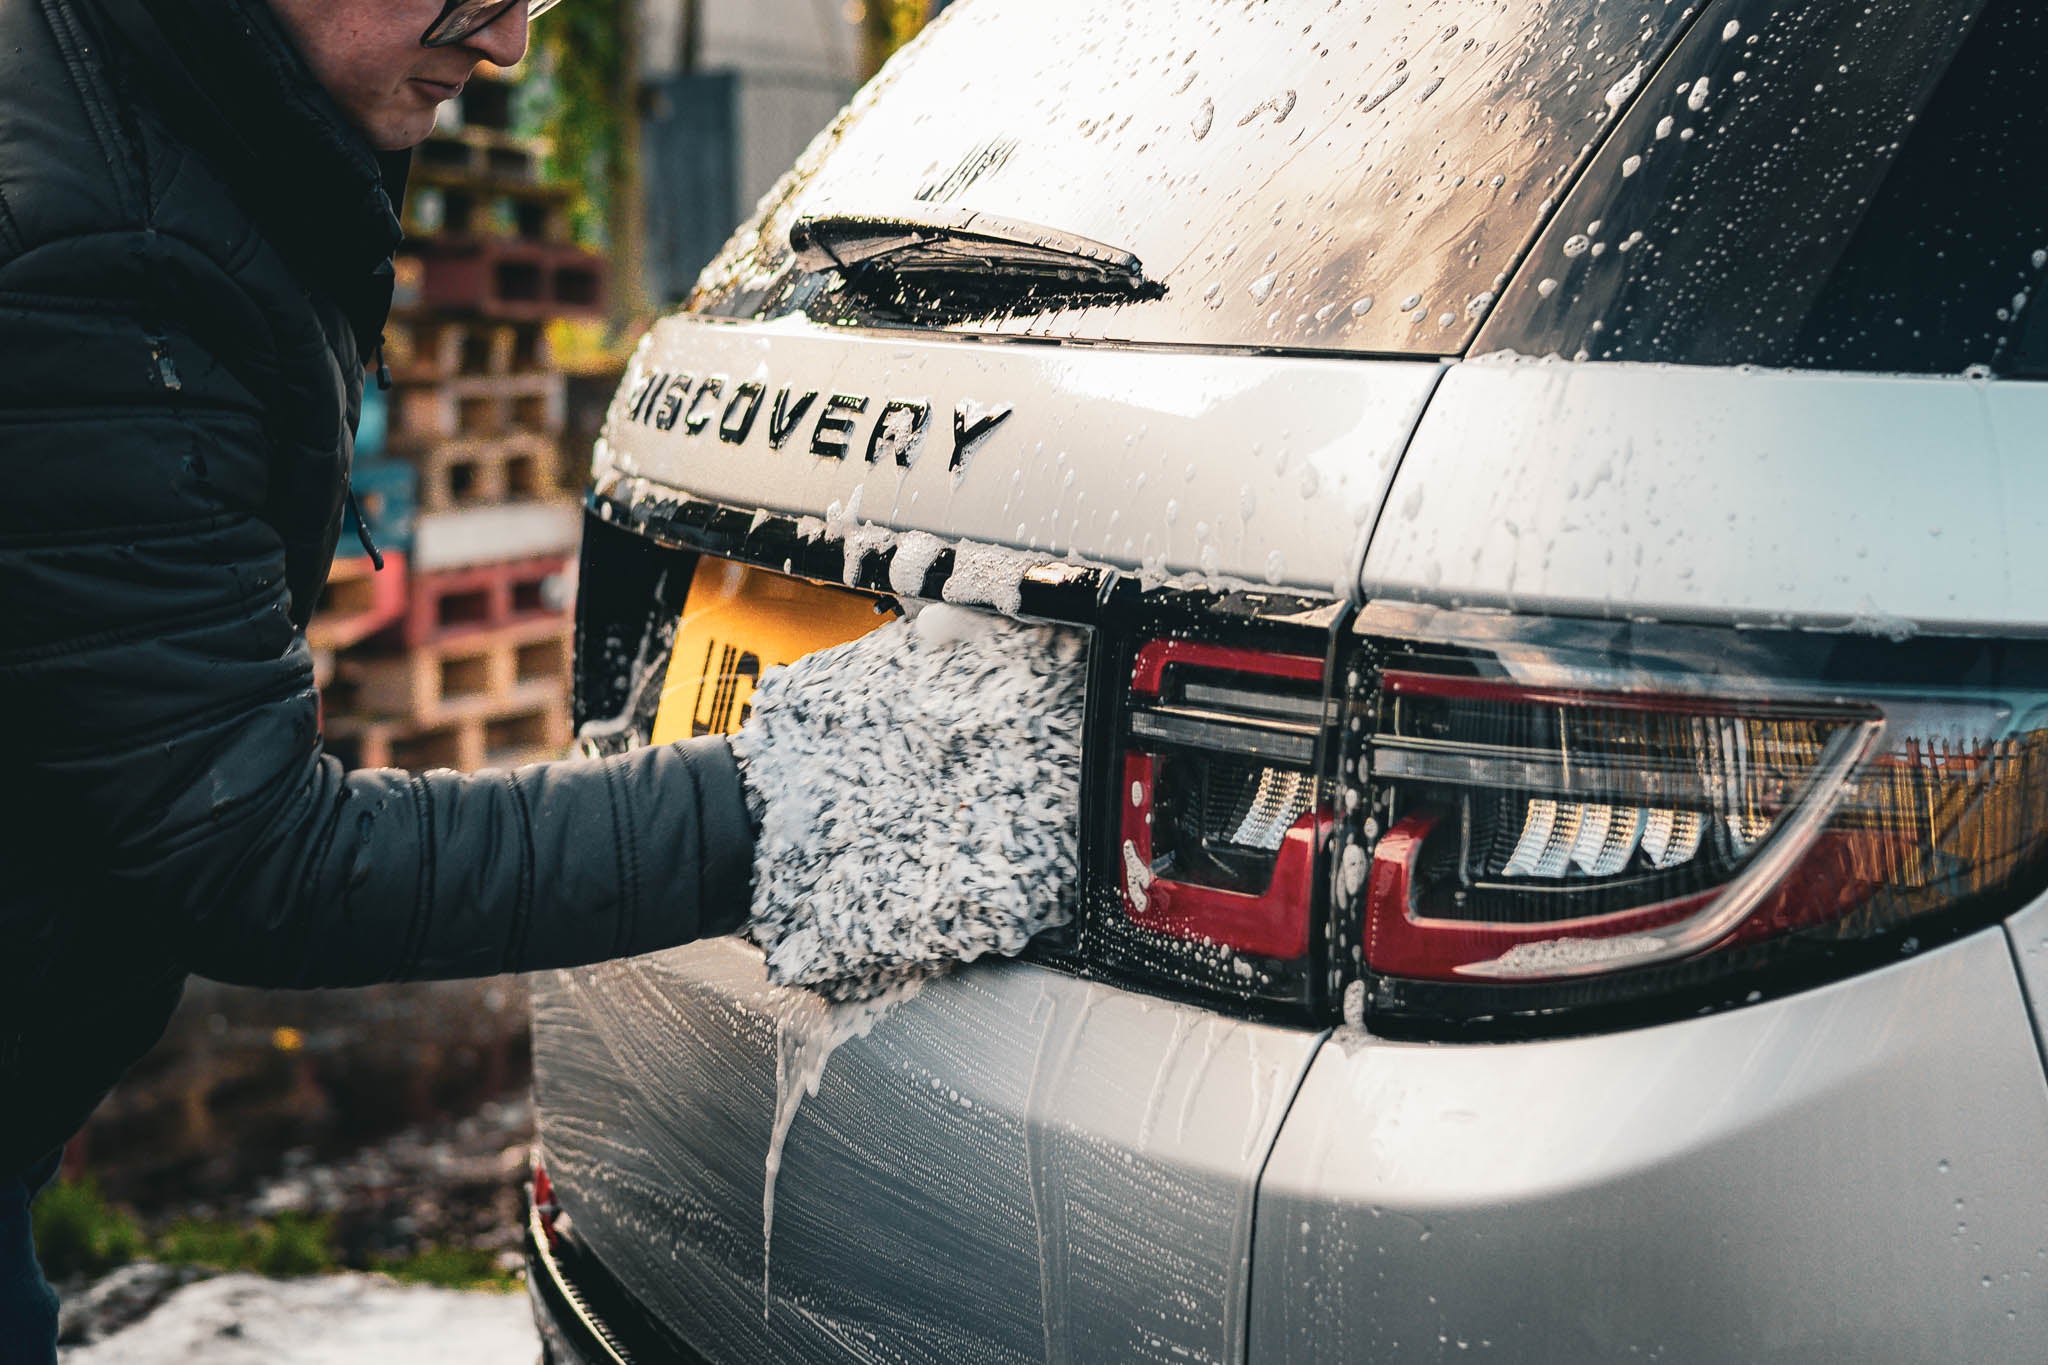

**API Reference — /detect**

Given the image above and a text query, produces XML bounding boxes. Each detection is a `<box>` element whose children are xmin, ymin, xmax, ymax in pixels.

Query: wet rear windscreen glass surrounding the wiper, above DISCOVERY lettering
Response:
<box><xmin>694</xmin><ymin>0</ymin><xmax>1696</xmax><ymax>354</ymax></box>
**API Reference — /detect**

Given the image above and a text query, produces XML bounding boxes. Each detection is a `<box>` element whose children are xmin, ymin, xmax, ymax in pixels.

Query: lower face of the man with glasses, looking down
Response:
<box><xmin>270</xmin><ymin>0</ymin><xmax>526</xmax><ymax>151</ymax></box>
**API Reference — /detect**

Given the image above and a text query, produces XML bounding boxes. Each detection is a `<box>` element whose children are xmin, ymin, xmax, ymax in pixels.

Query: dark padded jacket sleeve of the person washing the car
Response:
<box><xmin>0</xmin><ymin>231</ymin><xmax>752</xmax><ymax>986</ymax></box>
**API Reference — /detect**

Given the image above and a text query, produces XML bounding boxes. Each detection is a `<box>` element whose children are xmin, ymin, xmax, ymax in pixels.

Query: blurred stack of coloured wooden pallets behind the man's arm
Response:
<box><xmin>307</xmin><ymin>68</ymin><xmax>606</xmax><ymax>769</ymax></box>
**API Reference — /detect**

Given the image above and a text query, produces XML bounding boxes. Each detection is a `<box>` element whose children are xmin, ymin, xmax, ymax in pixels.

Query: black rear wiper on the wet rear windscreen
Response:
<box><xmin>788</xmin><ymin>205</ymin><xmax>1147</xmax><ymax>295</ymax></box>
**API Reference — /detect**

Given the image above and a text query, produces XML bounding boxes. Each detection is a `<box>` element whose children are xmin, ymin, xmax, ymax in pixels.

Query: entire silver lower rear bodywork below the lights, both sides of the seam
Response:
<box><xmin>532</xmin><ymin>921</ymin><xmax>2048</xmax><ymax>1365</ymax></box>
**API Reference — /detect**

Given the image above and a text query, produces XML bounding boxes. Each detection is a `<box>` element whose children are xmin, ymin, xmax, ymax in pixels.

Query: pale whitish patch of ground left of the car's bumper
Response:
<box><xmin>63</xmin><ymin>1275</ymin><xmax>541</xmax><ymax>1365</ymax></box>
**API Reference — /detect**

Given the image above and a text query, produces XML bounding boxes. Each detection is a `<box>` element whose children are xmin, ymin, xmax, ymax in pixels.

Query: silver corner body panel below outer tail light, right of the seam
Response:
<box><xmin>1251</xmin><ymin>925</ymin><xmax>2048</xmax><ymax>1365</ymax></box>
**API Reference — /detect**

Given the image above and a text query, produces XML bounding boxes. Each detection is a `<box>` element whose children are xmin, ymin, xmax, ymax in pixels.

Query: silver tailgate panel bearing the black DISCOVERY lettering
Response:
<box><xmin>596</xmin><ymin>317</ymin><xmax>1442</xmax><ymax>596</ymax></box>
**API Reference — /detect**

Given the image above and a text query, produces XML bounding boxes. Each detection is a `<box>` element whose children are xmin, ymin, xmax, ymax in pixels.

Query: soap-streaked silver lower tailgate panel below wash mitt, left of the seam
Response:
<box><xmin>535</xmin><ymin>939</ymin><xmax>1321</xmax><ymax>1365</ymax></box>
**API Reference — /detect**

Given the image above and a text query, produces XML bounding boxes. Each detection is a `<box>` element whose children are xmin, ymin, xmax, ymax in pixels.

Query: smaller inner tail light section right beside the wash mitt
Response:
<box><xmin>1118</xmin><ymin>641</ymin><xmax>1331</xmax><ymax>960</ymax></box>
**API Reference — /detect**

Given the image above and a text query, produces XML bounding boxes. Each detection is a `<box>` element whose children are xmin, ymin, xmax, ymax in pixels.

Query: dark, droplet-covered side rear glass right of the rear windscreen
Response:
<box><xmin>1475</xmin><ymin>0</ymin><xmax>2048</xmax><ymax>372</ymax></box>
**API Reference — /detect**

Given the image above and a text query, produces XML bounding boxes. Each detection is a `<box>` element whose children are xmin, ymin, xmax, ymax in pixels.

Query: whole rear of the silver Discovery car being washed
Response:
<box><xmin>532</xmin><ymin>0</ymin><xmax>2048</xmax><ymax>1361</ymax></box>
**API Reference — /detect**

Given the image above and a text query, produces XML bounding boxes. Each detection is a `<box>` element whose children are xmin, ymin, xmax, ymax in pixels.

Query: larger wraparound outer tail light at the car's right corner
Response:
<box><xmin>1339</xmin><ymin>608</ymin><xmax>2048</xmax><ymax>1031</ymax></box>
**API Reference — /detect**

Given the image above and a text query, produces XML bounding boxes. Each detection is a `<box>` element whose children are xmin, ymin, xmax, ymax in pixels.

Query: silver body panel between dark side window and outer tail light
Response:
<box><xmin>1362</xmin><ymin>358</ymin><xmax>2048</xmax><ymax>634</ymax></box>
